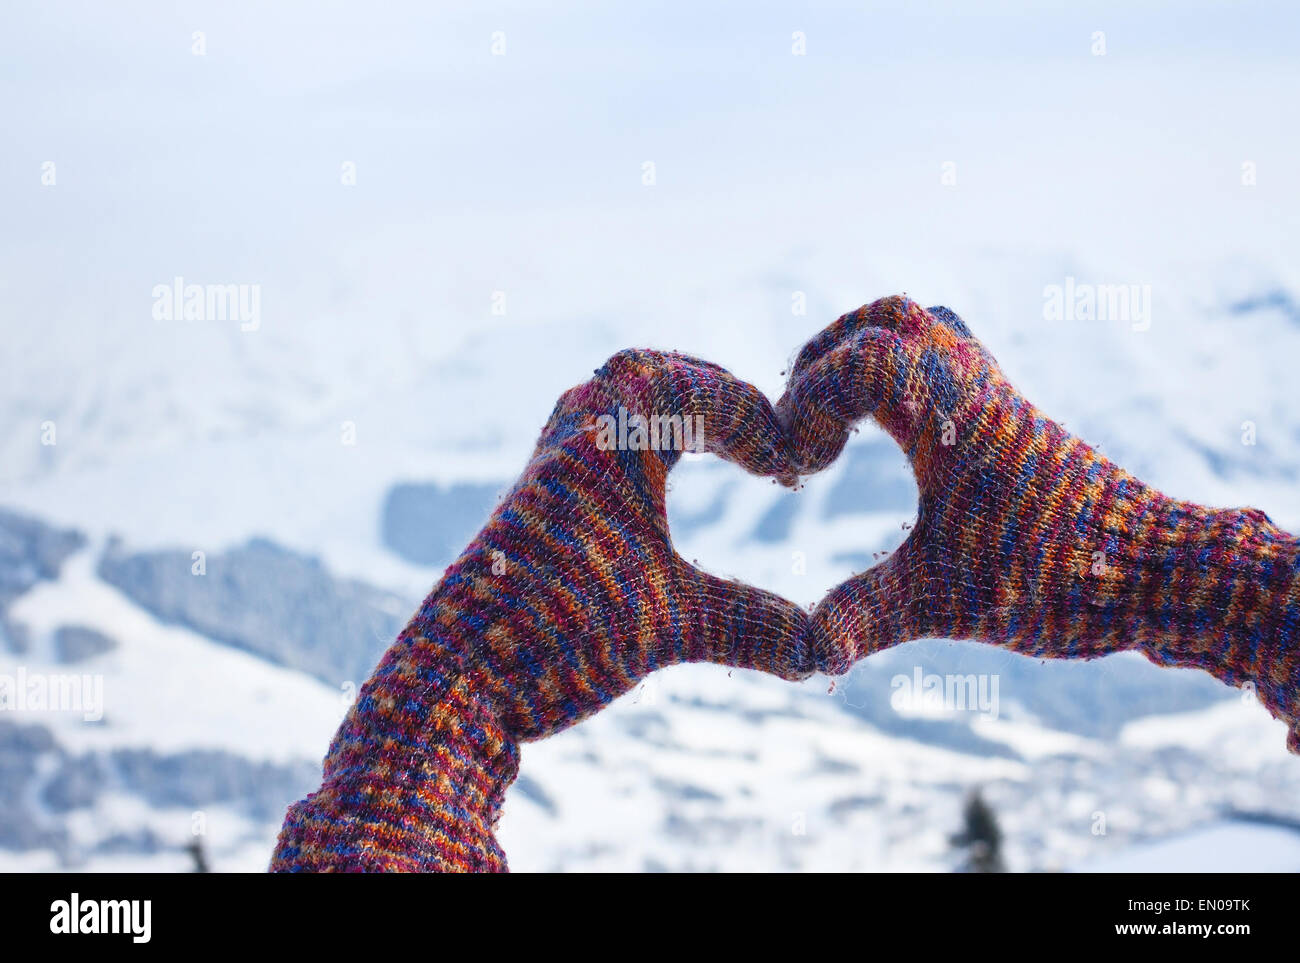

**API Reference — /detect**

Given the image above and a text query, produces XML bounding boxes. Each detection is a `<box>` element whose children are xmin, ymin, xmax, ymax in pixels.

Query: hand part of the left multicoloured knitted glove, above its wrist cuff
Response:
<box><xmin>384</xmin><ymin>351</ymin><xmax>813</xmax><ymax>739</ymax></box>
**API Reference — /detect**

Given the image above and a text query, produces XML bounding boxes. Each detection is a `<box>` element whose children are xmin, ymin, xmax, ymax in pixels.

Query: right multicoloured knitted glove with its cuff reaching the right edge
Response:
<box><xmin>777</xmin><ymin>298</ymin><xmax>1300</xmax><ymax>751</ymax></box>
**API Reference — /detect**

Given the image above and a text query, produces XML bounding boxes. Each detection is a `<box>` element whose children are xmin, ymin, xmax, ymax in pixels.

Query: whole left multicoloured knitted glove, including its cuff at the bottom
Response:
<box><xmin>272</xmin><ymin>351</ymin><xmax>813</xmax><ymax>871</ymax></box>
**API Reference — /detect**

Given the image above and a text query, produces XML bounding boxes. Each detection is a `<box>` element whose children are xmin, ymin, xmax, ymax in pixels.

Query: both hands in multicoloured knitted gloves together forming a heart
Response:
<box><xmin>272</xmin><ymin>298</ymin><xmax>1300</xmax><ymax>871</ymax></box>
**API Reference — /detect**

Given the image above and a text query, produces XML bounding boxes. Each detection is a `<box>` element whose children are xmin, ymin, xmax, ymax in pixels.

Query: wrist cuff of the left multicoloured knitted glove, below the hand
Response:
<box><xmin>270</xmin><ymin>626</ymin><xmax>519</xmax><ymax>872</ymax></box>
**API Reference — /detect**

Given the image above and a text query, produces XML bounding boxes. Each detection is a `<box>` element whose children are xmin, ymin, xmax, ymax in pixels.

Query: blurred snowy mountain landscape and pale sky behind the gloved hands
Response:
<box><xmin>0</xmin><ymin>0</ymin><xmax>1300</xmax><ymax>871</ymax></box>
